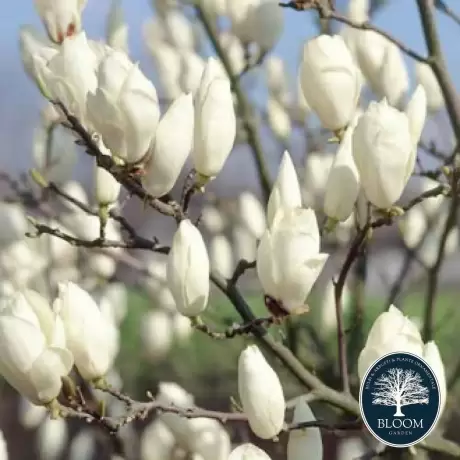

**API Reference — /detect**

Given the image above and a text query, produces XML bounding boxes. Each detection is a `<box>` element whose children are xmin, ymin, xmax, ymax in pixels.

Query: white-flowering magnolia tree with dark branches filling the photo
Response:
<box><xmin>0</xmin><ymin>0</ymin><xmax>460</xmax><ymax>460</ymax></box>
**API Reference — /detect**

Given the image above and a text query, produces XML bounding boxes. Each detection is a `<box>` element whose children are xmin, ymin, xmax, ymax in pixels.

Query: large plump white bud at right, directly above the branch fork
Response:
<box><xmin>353</xmin><ymin>99</ymin><xmax>416</xmax><ymax>209</ymax></box>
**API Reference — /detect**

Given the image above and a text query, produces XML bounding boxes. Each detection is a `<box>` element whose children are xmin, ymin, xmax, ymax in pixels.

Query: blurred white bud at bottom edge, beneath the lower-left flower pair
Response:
<box><xmin>37</xmin><ymin>418</ymin><xmax>68</xmax><ymax>460</ymax></box>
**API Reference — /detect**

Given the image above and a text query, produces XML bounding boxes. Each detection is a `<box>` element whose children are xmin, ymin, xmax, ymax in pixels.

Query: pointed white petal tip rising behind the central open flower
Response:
<box><xmin>267</xmin><ymin>150</ymin><xmax>302</xmax><ymax>226</ymax></box>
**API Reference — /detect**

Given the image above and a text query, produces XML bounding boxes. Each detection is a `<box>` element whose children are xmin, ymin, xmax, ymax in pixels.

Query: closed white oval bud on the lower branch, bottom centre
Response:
<box><xmin>238</xmin><ymin>345</ymin><xmax>285</xmax><ymax>439</ymax></box>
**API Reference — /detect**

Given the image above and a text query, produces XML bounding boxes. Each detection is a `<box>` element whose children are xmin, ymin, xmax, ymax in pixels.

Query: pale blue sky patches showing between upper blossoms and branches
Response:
<box><xmin>0</xmin><ymin>0</ymin><xmax>460</xmax><ymax>174</ymax></box>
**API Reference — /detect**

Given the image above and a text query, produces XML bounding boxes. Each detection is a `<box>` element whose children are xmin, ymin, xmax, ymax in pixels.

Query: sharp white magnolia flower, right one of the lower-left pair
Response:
<box><xmin>53</xmin><ymin>282</ymin><xmax>118</xmax><ymax>380</ymax></box>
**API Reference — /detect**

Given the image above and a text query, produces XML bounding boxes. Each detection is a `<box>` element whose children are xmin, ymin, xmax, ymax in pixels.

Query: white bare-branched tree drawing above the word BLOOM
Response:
<box><xmin>372</xmin><ymin>368</ymin><xmax>429</xmax><ymax>417</ymax></box>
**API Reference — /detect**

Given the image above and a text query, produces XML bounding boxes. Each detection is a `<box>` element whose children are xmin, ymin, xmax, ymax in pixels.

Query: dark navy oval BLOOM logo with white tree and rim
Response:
<box><xmin>359</xmin><ymin>353</ymin><xmax>440</xmax><ymax>447</ymax></box>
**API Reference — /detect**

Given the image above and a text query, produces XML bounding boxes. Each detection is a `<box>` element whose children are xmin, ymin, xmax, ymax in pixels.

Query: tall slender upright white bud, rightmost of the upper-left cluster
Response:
<box><xmin>192</xmin><ymin>57</ymin><xmax>236</xmax><ymax>177</ymax></box>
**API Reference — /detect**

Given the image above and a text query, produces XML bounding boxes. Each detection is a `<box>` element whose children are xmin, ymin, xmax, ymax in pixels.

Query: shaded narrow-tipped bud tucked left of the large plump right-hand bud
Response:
<box><xmin>324</xmin><ymin>117</ymin><xmax>361</xmax><ymax>222</ymax></box>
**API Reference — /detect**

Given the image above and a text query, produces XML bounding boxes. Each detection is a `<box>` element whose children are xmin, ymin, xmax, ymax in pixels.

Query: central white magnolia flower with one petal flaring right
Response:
<box><xmin>257</xmin><ymin>208</ymin><xmax>329</xmax><ymax>313</ymax></box>
